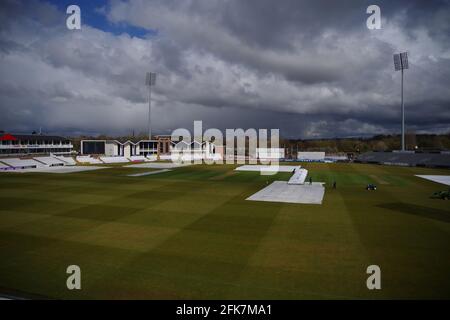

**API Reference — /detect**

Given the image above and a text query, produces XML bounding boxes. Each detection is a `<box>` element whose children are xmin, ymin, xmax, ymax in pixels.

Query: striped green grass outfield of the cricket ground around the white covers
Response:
<box><xmin>0</xmin><ymin>164</ymin><xmax>450</xmax><ymax>299</ymax></box>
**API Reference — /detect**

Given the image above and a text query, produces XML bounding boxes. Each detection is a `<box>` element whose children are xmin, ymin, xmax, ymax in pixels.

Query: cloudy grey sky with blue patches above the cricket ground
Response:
<box><xmin>0</xmin><ymin>0</ymin><xmax>450</xmax><ymax>138</ymax></box>
